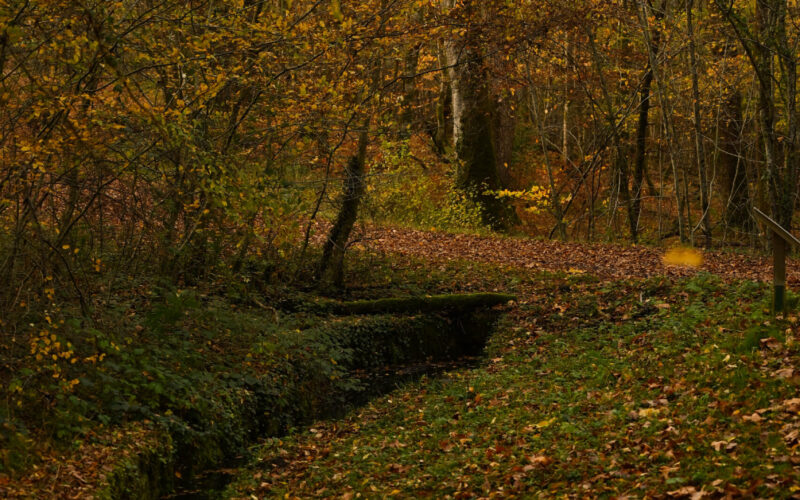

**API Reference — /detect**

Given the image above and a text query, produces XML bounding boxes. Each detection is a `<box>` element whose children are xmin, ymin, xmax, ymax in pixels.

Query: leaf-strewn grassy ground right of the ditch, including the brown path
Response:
<box><xmin>227</xmin><ymin>229</ymin><xmax>800</xmax><ymax>499</ymax></box>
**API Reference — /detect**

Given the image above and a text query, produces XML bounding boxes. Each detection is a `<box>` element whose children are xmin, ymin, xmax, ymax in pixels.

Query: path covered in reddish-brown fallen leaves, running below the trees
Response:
<box><xmin>362</xmin><ymin>227</ymin><xmax>800</xmax><ymax>285</ymax></box>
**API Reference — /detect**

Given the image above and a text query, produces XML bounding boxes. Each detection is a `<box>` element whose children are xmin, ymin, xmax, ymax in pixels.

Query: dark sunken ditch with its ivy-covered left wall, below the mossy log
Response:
<box><xmin>90</xmin><ymin>295</ymin><xmax>513</xmax><ymax>499</ymax></box>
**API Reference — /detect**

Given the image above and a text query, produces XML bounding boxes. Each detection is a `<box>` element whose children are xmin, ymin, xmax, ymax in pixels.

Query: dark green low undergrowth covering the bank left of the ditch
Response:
<box><xmin>0</xmin><ymin>248</ymin><xmax>504</xmax><ymax>477</ymax></box>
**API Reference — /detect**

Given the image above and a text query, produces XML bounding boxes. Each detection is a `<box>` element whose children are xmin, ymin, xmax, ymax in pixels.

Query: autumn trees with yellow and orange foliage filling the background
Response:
<box><xmin>0</xmin><ymin>0</ymin><xmax>799</xmax><ymax>298</ymax></box>
